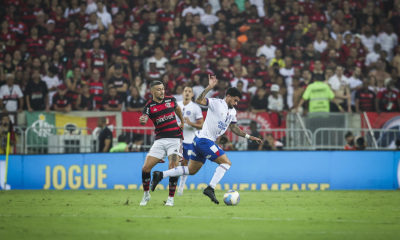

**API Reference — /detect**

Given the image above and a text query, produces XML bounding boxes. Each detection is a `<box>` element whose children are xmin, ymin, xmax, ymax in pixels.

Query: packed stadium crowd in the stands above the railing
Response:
<box><xmin>0</xmin><ymin>0</ymin><xmax>400</xmax><ymax>117</ymax></box>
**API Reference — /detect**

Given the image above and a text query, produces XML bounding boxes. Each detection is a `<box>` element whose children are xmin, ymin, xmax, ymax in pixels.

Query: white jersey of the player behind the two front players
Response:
<box><xmin>177</xmin><ymin>101</ymin><xmax>203</xmax><ymax>144</ymax></box>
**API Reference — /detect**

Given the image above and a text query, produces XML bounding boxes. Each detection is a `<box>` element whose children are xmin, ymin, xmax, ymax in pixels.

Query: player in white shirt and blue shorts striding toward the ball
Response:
<box><xmin>151</xmin><ymin>76</ymin><xmax>262</xmax><ymax>204</ymax></box>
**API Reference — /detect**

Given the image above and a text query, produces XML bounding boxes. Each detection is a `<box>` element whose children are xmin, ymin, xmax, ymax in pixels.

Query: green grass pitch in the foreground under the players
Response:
<box><xmin>0</xmin><ymin>190</ymin><xmax>400</xmax><ymax>240</ymax></box>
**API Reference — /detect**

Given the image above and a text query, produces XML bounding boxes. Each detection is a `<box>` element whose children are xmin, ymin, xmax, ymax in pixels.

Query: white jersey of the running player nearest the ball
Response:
<box><xmin>196</xmin><ymin>98</ymin><xmax>237</xmax><ymax>142</ymax></box>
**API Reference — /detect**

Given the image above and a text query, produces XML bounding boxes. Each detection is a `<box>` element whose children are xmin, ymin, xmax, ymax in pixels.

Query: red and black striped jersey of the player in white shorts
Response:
<box><xmin>143</xmin><ymin>96</ymin><xmax>182</xmax><ymax>140</ymax></box>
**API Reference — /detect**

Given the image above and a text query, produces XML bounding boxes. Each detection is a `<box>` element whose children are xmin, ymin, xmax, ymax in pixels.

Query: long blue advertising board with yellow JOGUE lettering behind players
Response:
<box><xmin>3</xmin><ymin>151</ymin><xmax>400</xmax><ymax>190</ymax></box>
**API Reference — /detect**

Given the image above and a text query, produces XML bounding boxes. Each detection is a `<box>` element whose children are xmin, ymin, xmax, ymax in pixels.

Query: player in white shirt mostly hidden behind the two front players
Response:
<box><xmin>177</xmin><ymin>86</ymin><xmax>204</xmax><ymax>195</ymax></box>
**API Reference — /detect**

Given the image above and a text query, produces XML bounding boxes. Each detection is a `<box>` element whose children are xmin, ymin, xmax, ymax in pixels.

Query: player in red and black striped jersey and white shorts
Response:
<box><xmin>139</xmin><ymin>81</ymin><xmax>184</xmax><ymax>206</ymax></box>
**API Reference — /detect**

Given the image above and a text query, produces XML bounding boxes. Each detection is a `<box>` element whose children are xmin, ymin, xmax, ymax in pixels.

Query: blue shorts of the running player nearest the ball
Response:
<box><xmin>190</xmin><ymin>137</ymin><xmax>225</xmax><ymax>163</ymax></box>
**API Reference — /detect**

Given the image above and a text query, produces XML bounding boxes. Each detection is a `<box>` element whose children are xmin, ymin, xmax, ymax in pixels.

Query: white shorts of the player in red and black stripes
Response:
<box><xmin>147</xmin><ymin>138</ymin><xmax>182</xmax><ymax>160</ymax></box>
